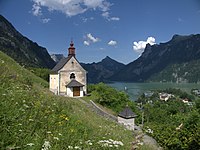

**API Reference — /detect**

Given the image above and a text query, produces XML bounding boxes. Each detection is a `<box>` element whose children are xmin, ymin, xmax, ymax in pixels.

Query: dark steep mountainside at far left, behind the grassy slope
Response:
<box><xmin>0</xmin><ymin>15</ymin><xmax>55</xmax><ymax>68</ymax></box>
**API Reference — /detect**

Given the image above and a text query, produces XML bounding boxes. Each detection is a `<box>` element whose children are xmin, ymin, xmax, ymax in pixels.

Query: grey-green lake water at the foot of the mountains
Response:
<box><xmin>108</xmin><ymin>82</ymin><xmax>200</xmax><ymax>100</ymax></box>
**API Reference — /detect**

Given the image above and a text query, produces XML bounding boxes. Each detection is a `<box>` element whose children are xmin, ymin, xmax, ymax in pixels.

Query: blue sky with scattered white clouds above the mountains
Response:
<box><xmin>0</xmin><ymin>0</ymin><xmax>200</xmax><ymax>64</ymax></box>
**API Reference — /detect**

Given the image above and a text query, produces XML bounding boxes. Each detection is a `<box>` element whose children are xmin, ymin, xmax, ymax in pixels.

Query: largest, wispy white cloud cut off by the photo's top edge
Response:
<box><xmin>32</xmin><ymin>0</ymin><xmax>111</xmax><ymax>16</ymax></box>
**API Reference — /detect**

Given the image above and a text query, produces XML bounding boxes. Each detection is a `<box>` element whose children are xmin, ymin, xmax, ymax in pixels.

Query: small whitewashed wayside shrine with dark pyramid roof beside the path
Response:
<box><xmin>117</xmin><ymin>106</ymin><xmax>136</xmax><ymax>130</ymax></box>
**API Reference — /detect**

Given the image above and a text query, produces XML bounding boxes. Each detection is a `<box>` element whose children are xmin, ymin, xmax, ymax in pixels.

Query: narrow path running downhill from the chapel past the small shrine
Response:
<box><xmin>79</xmin><ymin>98</ymin><xmax>162</xmax><ymax>150</ymax></box>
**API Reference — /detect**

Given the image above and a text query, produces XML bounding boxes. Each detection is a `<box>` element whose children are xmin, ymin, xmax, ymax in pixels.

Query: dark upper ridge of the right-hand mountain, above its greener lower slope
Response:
<box><xmin>110</xmin><ymin>34</ymin><xmax>200</xmax><ymax>82</ymax></box>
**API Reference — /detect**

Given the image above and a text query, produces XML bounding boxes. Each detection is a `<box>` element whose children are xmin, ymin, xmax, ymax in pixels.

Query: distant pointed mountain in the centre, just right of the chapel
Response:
<box><xmin>81</xmin><ymin>56</ymin><xmax>125</xmax><ymax>83</ymax></box>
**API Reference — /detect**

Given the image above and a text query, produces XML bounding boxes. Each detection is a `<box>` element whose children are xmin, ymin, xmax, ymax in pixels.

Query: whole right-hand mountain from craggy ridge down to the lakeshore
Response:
<box><xmin>110</xmin><ymin>34</ymin><xmax>200</xmax><ymax>82</ymax></box>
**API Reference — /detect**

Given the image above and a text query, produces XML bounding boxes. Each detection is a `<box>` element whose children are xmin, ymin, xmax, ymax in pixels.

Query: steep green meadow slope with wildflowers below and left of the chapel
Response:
<box><xmin>0</xmin><ymin>52</ymin><xmax>133</xmax><ymax>149</ymax></box>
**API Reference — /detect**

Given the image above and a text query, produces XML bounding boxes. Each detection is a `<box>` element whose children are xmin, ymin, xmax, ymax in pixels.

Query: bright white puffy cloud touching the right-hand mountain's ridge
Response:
<box><xmin>133</xmin><ymin>37</ymin><xmax>156</xmax><ymax>53</ymax></box>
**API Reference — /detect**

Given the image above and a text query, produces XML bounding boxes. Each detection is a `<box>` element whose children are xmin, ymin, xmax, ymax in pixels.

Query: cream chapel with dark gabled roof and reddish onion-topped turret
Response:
<box><xmin>49</xmin><ymin>41</ymin><xmax>87</xmax><ymax>97</ymax></box>
